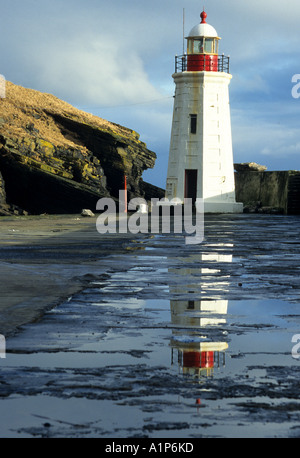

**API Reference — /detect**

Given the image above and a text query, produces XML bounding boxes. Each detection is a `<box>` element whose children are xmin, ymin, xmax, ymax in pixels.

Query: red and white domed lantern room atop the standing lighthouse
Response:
<box><xmin>187</xmin><ymin>11</ymin><xmax>220</xmax><ymax>72</ymax></box>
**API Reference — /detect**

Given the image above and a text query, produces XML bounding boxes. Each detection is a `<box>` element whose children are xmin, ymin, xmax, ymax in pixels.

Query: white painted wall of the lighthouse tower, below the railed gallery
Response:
<box><xmin>166</xmin><ymin>71</ymin><xmax>243</xmax><ymax>213</ymax></box>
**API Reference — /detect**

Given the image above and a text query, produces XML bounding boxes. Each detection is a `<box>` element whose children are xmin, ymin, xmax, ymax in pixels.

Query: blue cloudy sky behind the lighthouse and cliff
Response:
<box><xmin>0</xmin><ymin>0</ymin><xmax>300</xmax><ymax>188</ymax></box>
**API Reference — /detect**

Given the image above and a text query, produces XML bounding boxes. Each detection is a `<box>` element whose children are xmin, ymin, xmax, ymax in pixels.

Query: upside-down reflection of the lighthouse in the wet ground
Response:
<box><xmin>170</xmin><ymin>250</ymin><xmax>232</xmax><ymax>377</ymax></box>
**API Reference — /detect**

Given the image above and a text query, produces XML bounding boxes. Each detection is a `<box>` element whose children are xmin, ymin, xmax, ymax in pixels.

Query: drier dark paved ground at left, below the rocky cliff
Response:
<box><xmin>0</xmin><ymin>215</ymin><xmax>132</xmax><ymax>337</ymax></box>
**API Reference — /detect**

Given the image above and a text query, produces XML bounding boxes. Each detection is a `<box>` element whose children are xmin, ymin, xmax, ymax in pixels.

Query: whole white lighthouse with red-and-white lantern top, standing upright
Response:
<box><xmin>166</xmin><ymin>11</ymin><xmax>243</xmax><ymax>213</ymax></box>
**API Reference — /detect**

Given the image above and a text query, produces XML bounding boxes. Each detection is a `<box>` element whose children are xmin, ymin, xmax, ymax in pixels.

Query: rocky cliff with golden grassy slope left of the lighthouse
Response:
<box><xmin>0</xmin><ymin>82</ymin><xmax>156</xmax><ymax>215</ymax></box>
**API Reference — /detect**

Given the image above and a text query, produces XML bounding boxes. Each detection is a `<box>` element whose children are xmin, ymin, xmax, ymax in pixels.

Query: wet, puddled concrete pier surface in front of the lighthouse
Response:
<box><xmin>0</xmin><ymin>215</ymin><xmax>300</xmax><ymax>438</ymax></box>
